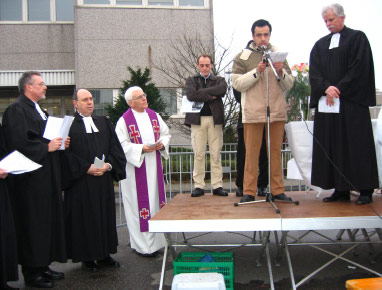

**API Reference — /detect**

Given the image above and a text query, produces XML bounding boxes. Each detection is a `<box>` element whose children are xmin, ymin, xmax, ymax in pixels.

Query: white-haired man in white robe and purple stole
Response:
<box><xmin>116</xmin><ymin>87</ymin><xmax>171</xmax><ymax>257</ymax></box>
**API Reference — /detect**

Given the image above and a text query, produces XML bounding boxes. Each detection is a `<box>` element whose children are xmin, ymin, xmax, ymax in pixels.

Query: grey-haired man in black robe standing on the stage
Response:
<box><xmin>309</xmin><ymin>4</ymin><xmax>378</xmax><ymax>205</ymax></box>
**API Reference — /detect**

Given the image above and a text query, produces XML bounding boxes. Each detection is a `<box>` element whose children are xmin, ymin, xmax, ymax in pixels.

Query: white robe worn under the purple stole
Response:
<box><xmin>115</xmin><ymin>110</ymin><xmax>171</xmax><ymax>254</ymax></box>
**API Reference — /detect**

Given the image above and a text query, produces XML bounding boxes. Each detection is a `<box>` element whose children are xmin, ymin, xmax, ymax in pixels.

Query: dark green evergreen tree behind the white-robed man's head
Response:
<box><xmin>106</xmin><ymin>66</ymin><xmax>168</xmax><ymax>124</ymax></box>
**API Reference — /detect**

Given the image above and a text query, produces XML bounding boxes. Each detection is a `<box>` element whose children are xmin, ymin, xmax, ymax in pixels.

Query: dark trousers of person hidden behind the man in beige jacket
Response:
<box><xmin>236</xmin><ymin>128</ymin><xmax>268</xmax><ymax>189</ymax></box>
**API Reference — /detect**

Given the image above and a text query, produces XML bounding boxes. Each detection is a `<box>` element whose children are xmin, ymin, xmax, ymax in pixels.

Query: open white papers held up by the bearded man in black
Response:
<box><xmin>43</xmin><ymin>116</ymin><xmax>74</xmax><ymax>150</ymax></box>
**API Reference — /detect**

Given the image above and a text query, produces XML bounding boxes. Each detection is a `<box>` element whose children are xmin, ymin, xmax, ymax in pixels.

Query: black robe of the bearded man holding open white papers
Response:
<box><xmin>3</xmin><ymin>95</ymin><xmax>66</xmax><ymax>267</ymax></box>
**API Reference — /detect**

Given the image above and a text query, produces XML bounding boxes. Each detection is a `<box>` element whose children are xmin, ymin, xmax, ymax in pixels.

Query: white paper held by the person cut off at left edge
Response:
<box><xmin>0</xmin><ymin>150</ymin><xmax>42</xmax><ymax>174</ymax></box>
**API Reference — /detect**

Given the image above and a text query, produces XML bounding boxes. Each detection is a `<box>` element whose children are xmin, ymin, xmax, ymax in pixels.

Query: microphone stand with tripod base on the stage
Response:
<box><xmin>234</xmin><ymin>49</ymin><xmax>299</xmax><ymax>214</ymax></box>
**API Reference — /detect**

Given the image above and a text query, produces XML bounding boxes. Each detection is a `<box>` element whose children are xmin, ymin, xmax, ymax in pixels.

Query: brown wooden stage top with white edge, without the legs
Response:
<box><xmin>149</xmin><ymin>191</ymin><xmax>382</xmax><ymax>232</ymax></box>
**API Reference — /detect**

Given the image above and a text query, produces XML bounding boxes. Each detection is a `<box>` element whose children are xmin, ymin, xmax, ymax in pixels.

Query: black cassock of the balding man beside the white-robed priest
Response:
<box><xmin>63</xmin><ymin>113</ymin><xmax>126</xmax><ymax>262</ymax></box>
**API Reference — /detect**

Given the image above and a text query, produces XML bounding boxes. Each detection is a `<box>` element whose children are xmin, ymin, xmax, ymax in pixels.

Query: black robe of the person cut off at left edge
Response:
<box><xmin>0</xmin><ymin>125</ymin><xmax>18</xmax><ymax>288</ymax></box>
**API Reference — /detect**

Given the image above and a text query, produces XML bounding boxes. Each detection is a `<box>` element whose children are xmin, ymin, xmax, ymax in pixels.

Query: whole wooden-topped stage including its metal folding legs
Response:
<box><xmin>149</xmin><ymin>191</ymin><xmax>382</xmax><ymax>289</ymax></box>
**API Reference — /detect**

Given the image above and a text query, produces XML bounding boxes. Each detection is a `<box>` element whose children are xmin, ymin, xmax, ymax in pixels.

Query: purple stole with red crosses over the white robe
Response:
<box><xmin>123</xmin><ymin>108</ymin><xmax>166</xmax><ymax>232</ymax></box>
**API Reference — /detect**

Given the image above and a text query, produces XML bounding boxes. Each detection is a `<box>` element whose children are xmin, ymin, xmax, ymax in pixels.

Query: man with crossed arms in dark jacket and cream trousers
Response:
<box><xmin>184</xmin><ymin>55</ymin><xmax>228</xmax><ymax>197</ymax></box>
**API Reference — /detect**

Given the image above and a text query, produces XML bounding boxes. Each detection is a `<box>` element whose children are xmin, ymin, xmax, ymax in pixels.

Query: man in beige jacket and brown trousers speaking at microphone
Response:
<box><xmin>232</xmin><ymin>19</ymin><xmax>293</xmax><ymax>202</ymax></box>
